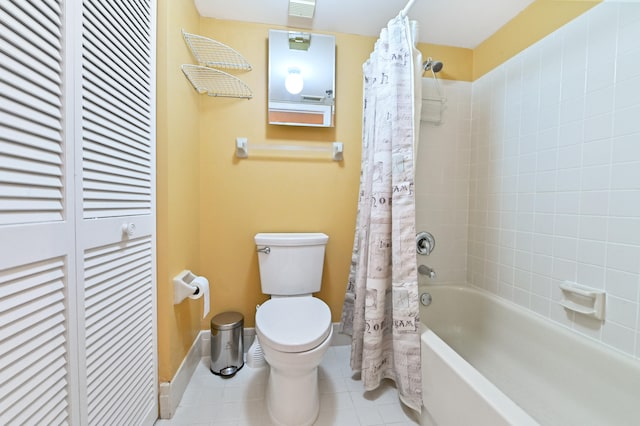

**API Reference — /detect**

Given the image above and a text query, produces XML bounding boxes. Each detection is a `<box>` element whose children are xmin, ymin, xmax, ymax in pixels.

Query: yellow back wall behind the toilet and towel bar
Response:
<box><xmin>200</xmin><ymin>19</ymin><xmax>375</xmax><ymax>328</ymax></box>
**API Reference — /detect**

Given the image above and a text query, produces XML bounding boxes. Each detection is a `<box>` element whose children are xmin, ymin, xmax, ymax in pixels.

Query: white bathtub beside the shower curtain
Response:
<box><xmin>421</xmin><ymin>286</ymin><xmax>640</xmax><ymax>426</ymax></box>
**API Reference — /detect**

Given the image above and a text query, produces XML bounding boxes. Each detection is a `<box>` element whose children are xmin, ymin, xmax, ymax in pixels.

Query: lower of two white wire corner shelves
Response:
<box><xmin>182</xmin><ymin>64</ymin><xmax>253</xmax><ymax>99</ymax></box>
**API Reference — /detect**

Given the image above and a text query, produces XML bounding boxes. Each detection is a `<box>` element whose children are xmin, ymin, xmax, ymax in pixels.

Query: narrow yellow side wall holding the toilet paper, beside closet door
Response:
<box><xmin>157</xmin><ymin>0</ymin><xmax>200</xmax><ymax>382</ymax></box>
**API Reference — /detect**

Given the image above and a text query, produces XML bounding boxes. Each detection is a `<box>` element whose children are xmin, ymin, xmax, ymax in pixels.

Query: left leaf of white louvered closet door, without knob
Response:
<box><xmin>0</xmin><ymin>0</ymin><xmax>78</xmax><ymax>425</ymax></box>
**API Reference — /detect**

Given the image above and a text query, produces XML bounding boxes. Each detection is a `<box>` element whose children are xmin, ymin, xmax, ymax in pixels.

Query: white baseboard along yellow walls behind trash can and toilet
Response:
<box><xmin>159</xmin><ymin>322</ymin><xmax>351</xmax><ymax>419</ymax></box>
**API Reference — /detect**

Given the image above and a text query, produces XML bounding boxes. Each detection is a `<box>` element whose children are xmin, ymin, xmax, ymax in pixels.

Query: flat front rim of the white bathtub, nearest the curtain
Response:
<box><xmin>421</xmin><ymin>326</ymin><xmax>538</xmax><ymax>426</ymax></box>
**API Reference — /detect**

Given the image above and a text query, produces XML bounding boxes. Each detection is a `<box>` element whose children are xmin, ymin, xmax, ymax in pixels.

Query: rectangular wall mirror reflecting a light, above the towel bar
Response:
<box><xmin>268</xmin><ymin>30</ymin><xmax>336</xmax><ymax>127</ymax></box>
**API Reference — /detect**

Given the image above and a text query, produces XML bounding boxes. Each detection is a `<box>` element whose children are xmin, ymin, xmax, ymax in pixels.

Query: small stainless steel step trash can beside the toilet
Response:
<box><xmin>210</xmin><ymin>312</ymin><xmax>244</xmax><ymax>377</ymax></box>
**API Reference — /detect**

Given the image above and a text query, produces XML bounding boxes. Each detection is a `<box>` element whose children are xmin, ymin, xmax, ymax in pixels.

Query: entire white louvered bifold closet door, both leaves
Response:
<box><xmin>0</xmin><ymin>0</ymin><xmax>157</xmax><ymax>425</ymax></box>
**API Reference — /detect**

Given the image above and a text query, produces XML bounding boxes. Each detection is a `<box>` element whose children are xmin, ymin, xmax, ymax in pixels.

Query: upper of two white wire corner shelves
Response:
<box><xmin>182</xmin><ymin>30</ymin><xmax>251</xmax><ymax>71</ymax></box>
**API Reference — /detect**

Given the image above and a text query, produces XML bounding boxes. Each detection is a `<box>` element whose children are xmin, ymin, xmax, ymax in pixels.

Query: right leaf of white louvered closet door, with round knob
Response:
<box><xmin>76</xmin><ymin>0</ymin><xmax>158</xmax><ymax>425</ymax></box>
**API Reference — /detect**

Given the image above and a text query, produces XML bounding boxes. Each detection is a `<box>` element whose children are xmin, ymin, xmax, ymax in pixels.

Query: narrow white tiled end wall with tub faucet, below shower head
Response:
<box><xmin>416</xmin><ymin>79</ymin><xmax>471</xmax><ymax>284</ymax></box>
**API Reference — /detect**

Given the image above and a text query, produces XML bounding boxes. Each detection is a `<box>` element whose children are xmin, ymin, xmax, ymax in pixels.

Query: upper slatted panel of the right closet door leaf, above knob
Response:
<box><xmin>82</xmin><ymin>1</ymin><xmax>153</xmax><ymax>225</ymax></box>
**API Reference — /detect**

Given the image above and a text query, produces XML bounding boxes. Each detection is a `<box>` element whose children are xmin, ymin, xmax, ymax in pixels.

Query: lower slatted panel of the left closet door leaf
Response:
<box><xmin>0</xmin><ymin>258</ymin><xmax>69</xmax><ymax>424</ymax></box>
